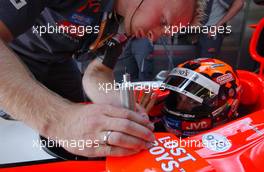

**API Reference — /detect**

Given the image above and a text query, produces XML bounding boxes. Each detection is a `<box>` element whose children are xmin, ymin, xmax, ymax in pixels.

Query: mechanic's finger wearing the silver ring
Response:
<box><xmin>102</xmin><ymin>132</ymin><xmax>152</xmax><ymax>150</ymax></box>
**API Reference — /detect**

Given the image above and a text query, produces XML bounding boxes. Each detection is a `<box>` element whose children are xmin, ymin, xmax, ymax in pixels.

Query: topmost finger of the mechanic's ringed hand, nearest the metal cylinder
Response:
<box><xmin>105</xmin><ymin>106</ymin><xmax>152</xmax><ymax>129</ymax></box>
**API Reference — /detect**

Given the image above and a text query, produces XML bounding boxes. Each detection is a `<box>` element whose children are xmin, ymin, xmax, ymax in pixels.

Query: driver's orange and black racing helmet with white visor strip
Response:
<box><xmin>163</xmin><ymin>58</ymin><xmax>241</xmax><ymax>137</ymax></box>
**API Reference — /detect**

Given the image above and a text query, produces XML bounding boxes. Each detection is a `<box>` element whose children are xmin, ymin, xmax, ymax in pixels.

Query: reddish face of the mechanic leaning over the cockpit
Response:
<box><xmin>125</xmin><ymin>0</ymin><xmax>195</xmax><ymax>42</ymax></box>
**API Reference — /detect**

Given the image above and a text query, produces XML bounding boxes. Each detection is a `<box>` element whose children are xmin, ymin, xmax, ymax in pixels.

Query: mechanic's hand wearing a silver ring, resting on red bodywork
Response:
<box><xmin>52</xmin><ymin>104</ymin><xmax>155</xmax><ymax>157</ymax></box>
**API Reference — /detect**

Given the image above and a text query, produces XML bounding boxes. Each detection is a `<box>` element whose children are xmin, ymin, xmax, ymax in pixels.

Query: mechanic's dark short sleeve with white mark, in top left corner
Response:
<box><xmin>0</xmin><ymin>0</ymin><xmax>46</xmax><ymax>37</ymax></box>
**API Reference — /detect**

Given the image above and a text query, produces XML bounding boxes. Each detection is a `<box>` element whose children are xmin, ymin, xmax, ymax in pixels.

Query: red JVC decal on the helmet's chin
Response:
<box><xmin>182</xmin><ymin>119</ymin><xmax>212</xmax><ymax>130</ymax></box>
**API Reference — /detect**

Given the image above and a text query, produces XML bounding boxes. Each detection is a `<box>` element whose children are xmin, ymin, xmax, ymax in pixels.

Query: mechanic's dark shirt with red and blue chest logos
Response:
<box><xmin>0</xmin><ymin>0</ymin><xmax>118</xmax><ymax>66</ymax></box>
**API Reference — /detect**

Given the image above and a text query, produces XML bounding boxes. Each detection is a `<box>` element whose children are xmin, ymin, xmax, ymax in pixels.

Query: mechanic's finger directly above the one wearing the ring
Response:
<box><xmin>104</xmin><ymin>118</ymin><xmax>155</xmax><ymax>142</ymax></box>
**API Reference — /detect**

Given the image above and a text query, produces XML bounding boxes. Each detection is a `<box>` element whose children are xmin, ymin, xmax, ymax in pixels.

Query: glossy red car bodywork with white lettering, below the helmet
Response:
<box><xmin>0</xmin><ymin>106</ymin><xmax>264</xmax><ymax>172</ymax></box>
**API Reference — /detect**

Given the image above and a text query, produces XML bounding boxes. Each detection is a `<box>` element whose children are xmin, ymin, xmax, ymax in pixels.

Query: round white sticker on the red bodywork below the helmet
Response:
<box><xmin>202</xmin><ymin>133</ymin><xmax>232</xmax><ymax>152</ymax></box>
